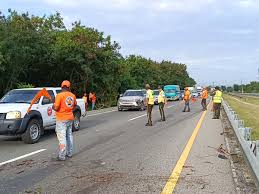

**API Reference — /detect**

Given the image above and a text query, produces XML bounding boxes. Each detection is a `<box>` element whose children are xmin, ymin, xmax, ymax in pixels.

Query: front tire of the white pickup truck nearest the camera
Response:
<box><xmin>22</xmin><ymin>119</ymin><xmax>42</xmax><ymax>144</ymax></box>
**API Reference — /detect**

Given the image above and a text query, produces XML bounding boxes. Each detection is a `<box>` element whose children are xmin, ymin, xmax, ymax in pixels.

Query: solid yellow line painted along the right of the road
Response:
<box><xmin>162</xmin><ymin>105</ymin><xmax>210</xmax><ymax>194</ymax></box>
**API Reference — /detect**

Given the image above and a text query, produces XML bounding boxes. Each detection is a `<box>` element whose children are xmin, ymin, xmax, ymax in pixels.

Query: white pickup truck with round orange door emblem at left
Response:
<box><xmin>0</xmin><ymin>88</ymin><xmax>86</xmax><ymax>144</ymax></box>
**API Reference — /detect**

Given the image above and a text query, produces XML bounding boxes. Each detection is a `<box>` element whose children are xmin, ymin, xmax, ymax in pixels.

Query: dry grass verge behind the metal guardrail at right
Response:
<box><xmin>224</xmin><ymin>94</ymin><xmax>259</xmax><ymax>140</ymax></box>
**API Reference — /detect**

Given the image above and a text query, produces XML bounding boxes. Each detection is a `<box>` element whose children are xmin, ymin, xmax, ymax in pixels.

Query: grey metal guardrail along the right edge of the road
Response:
<box><xmin>222</xmin><ymin>100</ymin><xmax>259</xmax><ymax>188</ymax></box>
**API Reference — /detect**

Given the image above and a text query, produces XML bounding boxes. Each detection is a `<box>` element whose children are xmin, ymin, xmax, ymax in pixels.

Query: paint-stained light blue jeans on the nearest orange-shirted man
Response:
<box><xmin>56</xmin><ymin>121</ymin><xmax>73</xmax><ymax>160</ymax></box>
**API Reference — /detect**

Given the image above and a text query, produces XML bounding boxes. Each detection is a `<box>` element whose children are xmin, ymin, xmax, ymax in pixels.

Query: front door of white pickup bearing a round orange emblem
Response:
<box><xmin>40</xmin><ymin>90</ymin><xmax>56</xmax><ymax>127</ymax></box>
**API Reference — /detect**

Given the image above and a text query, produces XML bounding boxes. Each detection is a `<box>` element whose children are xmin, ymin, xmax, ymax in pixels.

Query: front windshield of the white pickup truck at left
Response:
<box><xmin>0</xmin><ymin>90</ymin><xmax>39</xmax><ymax>104</ymax></box>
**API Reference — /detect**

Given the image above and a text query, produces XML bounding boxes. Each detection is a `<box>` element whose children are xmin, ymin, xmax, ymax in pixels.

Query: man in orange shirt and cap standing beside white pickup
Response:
<box><xmin>53</xmin><ymin>80</ymin><xmax>77</xmax><ymax>161</ymax></box>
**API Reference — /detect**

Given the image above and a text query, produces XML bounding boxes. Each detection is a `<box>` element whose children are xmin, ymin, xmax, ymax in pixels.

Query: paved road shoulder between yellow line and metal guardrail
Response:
<box><xmin>175</xmin><ymin>112</ymin><xmax>236</xmax><ymax>194</ymax></box>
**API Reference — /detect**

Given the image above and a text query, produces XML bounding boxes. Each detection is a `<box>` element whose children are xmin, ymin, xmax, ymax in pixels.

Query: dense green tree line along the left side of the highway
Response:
<box><xmin>0</xmin><ymin>10</ymin><xmax>195</xmax><ymax>105</ymax></box>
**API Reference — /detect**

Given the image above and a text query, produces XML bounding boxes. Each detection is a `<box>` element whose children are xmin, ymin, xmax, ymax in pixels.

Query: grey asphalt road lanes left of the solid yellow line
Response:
<box><xmin>0</xmin><ymin>102</ymin><xmax>236</xmax><ymax>194</ymax></box>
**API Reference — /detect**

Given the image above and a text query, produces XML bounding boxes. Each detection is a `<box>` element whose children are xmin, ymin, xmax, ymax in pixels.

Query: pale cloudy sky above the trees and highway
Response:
<box><xmin>0</xmin><ymin>0</ymin><xmax>259</xmax><ymax>85</ymax></box>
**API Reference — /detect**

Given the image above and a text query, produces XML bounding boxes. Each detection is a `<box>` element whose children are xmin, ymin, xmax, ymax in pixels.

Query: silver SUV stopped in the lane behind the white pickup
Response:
<box><xmin>118</xmin><ymin>90</ymin><xmax>146</xmax><ymax>111</ymax></box>
